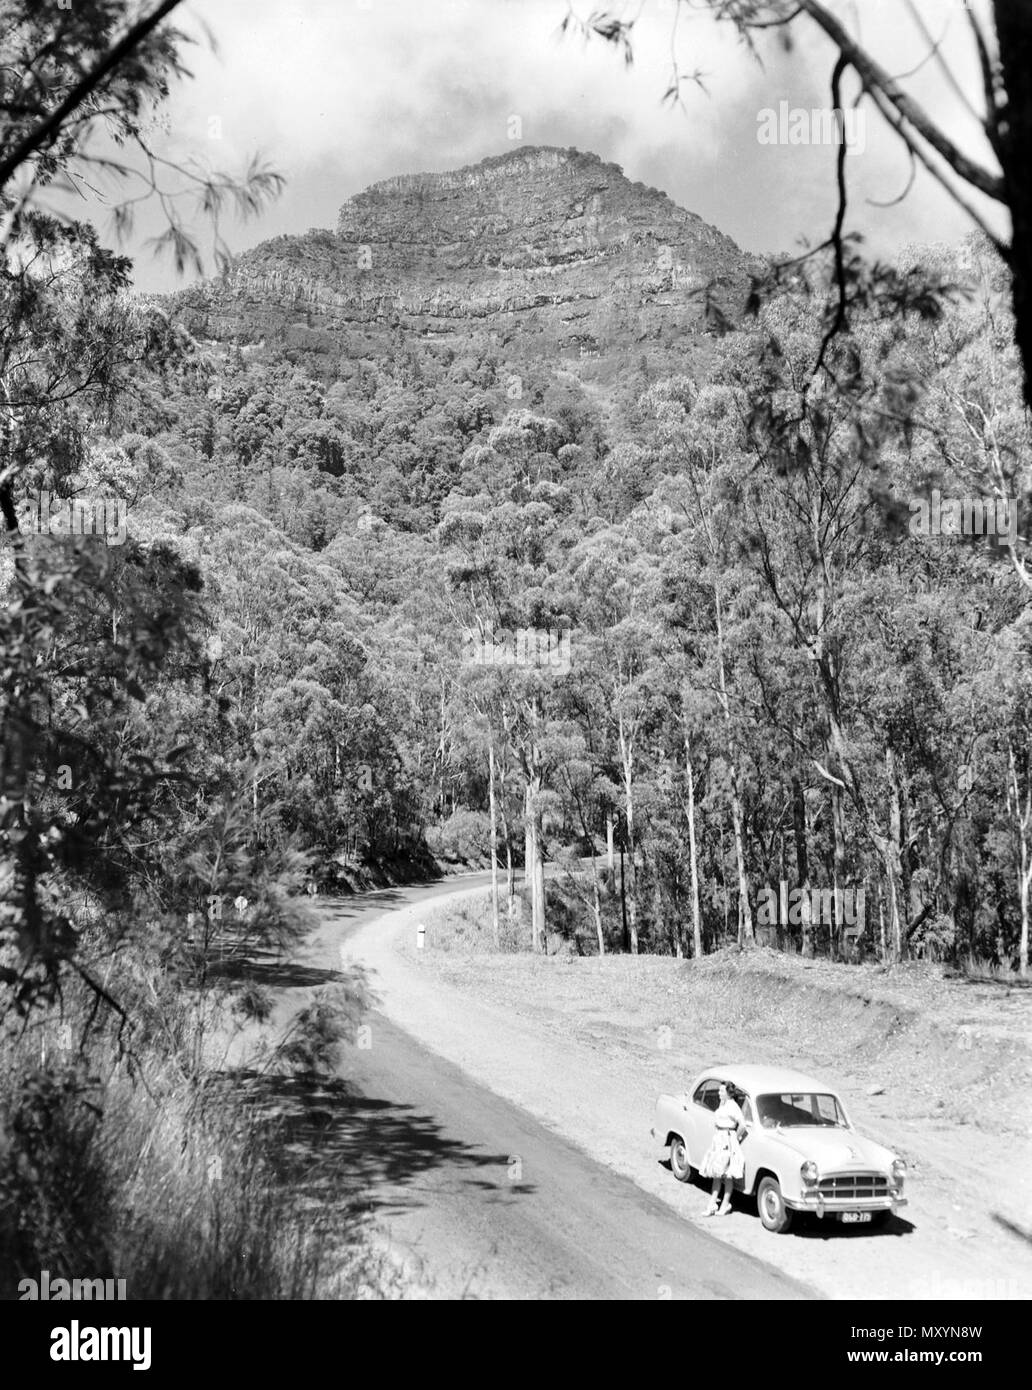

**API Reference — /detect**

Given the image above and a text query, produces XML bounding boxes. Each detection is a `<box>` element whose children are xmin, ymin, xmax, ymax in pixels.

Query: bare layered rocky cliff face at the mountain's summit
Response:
<box><xmin>177</xmin><ymin>146</ymin><xmax>754</xmax><ymax>357</ymax></box>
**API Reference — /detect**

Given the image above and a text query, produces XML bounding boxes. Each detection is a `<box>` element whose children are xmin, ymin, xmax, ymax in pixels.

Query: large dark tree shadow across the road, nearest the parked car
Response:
<box><xmin>226</xmin><ymin>1070</ymin><xmax>534</xmax><ymax>1213</ymax></box>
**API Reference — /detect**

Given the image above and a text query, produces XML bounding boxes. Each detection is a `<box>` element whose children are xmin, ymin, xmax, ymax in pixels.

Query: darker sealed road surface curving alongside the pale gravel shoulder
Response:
<box><xmin>298</xmin><ymin>876</ymin><xmax>815</xmax><ymax>1300</ymax></box>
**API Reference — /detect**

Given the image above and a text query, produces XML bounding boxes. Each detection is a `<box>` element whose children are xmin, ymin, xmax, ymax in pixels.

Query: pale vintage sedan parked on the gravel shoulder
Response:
<box><xmin>652</xmin><ymin>1065</ymin><xmax>907</xmax><ymax>1232</ymax></box>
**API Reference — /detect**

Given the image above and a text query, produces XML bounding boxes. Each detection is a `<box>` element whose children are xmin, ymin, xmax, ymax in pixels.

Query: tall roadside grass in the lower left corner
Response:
<box><xmin>0</xmin><ymin>967</ymin><xmax>398</xmax><ymax>1300</ymax></box>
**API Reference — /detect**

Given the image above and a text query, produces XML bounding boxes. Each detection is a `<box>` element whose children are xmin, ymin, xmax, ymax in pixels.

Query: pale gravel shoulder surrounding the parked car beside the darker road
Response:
<box><xmin>341</xmin><ymin>888</ymin><xmax>1032</xmax><ymax>1300</ymax></box>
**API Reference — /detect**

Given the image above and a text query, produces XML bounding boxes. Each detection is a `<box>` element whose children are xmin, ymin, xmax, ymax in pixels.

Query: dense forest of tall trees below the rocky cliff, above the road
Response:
<box><xmin>118</xmin><ymin>216</ymin><xmax>1028</xmax><ymax>978</ymax></box>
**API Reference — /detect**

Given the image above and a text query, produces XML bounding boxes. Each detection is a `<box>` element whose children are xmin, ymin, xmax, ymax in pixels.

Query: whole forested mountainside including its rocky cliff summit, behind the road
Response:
<box><xmin>88</xmin><ymin>150</ymin><xmax>1032</xmax><ymax>965</ymax></box>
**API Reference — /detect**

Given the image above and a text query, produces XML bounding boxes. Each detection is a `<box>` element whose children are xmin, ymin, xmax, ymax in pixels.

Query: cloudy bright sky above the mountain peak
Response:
<box><xmin>72</xmin><ymin>0</ymin><xmax>1006</xmax><ymax>292</ymax></box>
